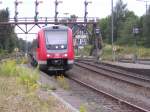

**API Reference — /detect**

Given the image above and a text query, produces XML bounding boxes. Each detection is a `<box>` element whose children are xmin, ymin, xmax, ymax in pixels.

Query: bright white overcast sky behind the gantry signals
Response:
<box><xmin>0</xmin><ymin>0</ymin><xmax>146</xmax><ymax>40</ymax></box>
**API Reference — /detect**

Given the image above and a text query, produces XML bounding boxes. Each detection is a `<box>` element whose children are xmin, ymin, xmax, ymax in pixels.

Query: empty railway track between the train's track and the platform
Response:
<box><xmin>75</xmin><ymin>61</ymin><xmax>150</xmax><ymax>89</ymax></box>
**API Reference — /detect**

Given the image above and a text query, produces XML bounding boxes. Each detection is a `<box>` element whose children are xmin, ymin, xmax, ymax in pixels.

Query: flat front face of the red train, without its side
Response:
<box><xmin>39</xmin><ymin>25</ymin><xmax>74</xmax><ymax>71</ymax></box>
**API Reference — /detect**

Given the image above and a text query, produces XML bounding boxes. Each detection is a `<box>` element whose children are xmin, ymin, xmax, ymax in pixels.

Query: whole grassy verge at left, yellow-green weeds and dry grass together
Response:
<box><xmin>0</xmin><ymin>60</ymin><xmax>69</xmax><ymax>112</ymax></box>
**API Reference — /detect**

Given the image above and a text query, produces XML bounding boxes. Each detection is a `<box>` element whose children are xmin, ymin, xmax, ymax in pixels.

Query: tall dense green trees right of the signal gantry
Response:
<box><xmin>99</xmin><ymin>0</ymin><xmax>150</xmax><ymax>47</ymax></box>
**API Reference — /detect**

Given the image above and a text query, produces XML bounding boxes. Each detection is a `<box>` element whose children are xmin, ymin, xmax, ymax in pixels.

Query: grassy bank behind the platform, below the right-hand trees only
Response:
<box><xmin>102</xmin><ymin>45</ymin><xmax>150</xmax><ymax>60</ymax></box>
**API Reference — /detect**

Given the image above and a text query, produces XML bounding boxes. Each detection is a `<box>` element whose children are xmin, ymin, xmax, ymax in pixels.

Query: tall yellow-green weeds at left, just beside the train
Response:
<box><xmin>0</xmin><ymin>60</ymin><xmax>39</xmax><ymax>90</ymax></box>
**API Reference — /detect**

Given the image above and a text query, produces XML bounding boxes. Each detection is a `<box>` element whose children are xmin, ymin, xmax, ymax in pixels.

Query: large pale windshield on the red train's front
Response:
<box><xmin>45</xmin><ymin>30</ymin><xmax>67</xmax><ymax>45</ymax></box>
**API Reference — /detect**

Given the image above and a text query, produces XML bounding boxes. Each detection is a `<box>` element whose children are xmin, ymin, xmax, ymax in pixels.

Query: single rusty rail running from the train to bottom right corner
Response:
<box><xmin>69</xmin><ymin>76</ymin><xmax>150</xmax><ymax>112</ymax></box>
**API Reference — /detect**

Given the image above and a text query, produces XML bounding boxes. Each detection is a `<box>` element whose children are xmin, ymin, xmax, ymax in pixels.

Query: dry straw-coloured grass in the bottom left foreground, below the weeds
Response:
<box><xmin>0</xmin><ymin>76</ymin><xmax>68</xmax><ymax>112</ymax></box>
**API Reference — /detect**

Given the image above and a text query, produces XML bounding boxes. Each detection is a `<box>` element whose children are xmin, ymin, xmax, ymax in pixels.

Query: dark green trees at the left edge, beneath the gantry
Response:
<box><xmin>0</xmin><ymin>8</ymin><xmax>25</xmax><ymax>54</ymax></box>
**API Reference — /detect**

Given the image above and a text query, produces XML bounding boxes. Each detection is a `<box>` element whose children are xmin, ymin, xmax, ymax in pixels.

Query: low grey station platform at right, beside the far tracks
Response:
<box><xmin>102</xmin><ymin>61</ymin><xmax>150</xmax><ymax>76</ymax></box>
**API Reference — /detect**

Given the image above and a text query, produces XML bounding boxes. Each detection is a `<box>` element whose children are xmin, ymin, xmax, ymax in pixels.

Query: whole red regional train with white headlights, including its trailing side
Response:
<box><xmin>31</xmin><ymin>25</ymin><xmax>74</xmax><ymax>71</ymax></box>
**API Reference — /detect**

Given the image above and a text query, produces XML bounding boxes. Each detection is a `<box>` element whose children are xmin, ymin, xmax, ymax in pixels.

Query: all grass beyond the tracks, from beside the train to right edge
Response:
<box><xmin>75</xmin><ymin>44</ymin><xmax>150</xmax><ymax>60</ymax></box>
